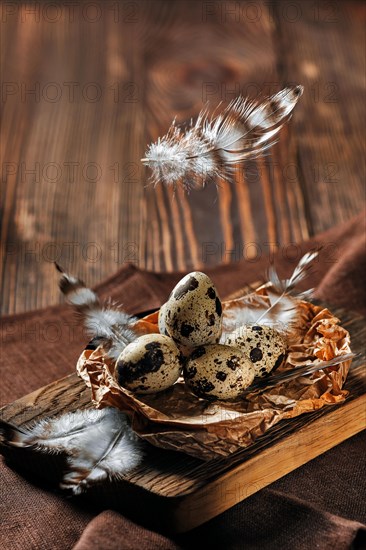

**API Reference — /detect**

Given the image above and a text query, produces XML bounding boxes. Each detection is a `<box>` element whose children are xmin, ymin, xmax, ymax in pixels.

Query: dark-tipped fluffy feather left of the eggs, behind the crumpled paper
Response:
<box><xmin>55</xmin><ymin>264</ymin><xmax>137</xmax><ymax>360</ymax></box>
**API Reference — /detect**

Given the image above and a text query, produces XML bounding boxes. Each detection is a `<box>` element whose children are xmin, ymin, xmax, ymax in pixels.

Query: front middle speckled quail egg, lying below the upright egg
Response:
<box><xmin>183</xmin><ymin>344</ymin><xmax>254</xmax><ymax>401</ymax></box>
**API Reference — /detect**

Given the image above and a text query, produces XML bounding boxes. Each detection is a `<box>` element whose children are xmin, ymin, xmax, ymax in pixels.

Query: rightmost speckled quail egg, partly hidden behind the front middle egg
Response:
<box><xmin>225</xmin><ymin>325</ymin><xmax>286</xmax><ymax>376</ymax></box>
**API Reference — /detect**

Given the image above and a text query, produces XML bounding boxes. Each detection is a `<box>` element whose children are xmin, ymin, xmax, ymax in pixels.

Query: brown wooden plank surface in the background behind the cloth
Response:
<box><xmin>0</xmin><ymin>0</ymin><xmax>365</xmax><ymax>313</ymax></box>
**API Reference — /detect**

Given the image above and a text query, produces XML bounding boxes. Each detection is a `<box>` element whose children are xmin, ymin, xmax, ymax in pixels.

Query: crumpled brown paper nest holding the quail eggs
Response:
<box><xmin>77</xmin><ymin>294</ymin><xmax>351</xmax><ymax>460</ymax></box>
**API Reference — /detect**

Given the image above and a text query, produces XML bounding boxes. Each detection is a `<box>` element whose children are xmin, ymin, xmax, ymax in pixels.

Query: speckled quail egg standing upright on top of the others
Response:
<box><xmin>161</xmin><ymin>271</ymin><xmax>222</xmax><ymax>348</ymax></box>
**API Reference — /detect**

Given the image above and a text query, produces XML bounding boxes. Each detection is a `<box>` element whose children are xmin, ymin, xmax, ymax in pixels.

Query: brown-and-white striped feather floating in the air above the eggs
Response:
<box><xmin>141</xmin><ymin>86</ymin><xmax>303</xmax><ymax>189</ymax></box>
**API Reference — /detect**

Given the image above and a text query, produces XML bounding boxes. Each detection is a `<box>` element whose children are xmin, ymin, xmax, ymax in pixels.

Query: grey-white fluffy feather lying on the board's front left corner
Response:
<box><xmin>0</xmin><ymin>408</ymin><xmax>142</xmax><ymax>494</ymax></box>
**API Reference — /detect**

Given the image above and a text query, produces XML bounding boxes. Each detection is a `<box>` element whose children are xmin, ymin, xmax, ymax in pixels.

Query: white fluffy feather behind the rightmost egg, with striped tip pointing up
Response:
<box><xmin>221</xmin><ymin>250</ymin><xmax>319</xmax><ymax>341</ymax></box>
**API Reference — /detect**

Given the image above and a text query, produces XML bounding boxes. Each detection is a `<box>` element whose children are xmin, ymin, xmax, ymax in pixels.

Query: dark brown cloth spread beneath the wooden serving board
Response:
<box><xmin>0</xmin><ymin>212</ymin><xmax>366</xmax><ymax>550</ymax></box>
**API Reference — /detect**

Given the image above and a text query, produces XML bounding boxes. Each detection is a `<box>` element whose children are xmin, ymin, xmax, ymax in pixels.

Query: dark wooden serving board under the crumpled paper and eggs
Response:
<box><xmin>0</xmin><ymin>308</ymin><xmax>366</xmax><ymax>532</ymax></box>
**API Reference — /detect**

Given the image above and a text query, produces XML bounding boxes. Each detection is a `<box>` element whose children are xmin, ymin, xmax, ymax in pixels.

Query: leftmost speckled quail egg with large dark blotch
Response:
<box><xmin>115</xmin><ymin>334</ymin><xmax>182</xmax><ymax>394</ymax></box>
